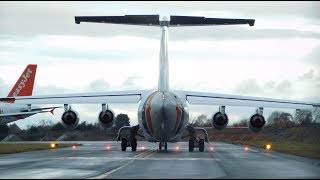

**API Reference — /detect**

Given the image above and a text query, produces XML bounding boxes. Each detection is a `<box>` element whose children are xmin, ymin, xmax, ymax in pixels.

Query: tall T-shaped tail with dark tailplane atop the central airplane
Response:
<box><xmin>75</xmin><ymin>15</ymin><xmax>255</xmax><ymax>92</ymax></box>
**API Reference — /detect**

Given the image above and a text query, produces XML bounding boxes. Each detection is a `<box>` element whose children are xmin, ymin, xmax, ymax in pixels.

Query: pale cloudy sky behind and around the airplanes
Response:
<box><xmin>0</xmin><ymin>1</ymin><xmax>320</xmax><ymax>128</ymax></box>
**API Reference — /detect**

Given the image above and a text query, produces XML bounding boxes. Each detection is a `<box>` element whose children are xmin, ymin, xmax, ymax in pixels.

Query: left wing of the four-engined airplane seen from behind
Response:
<box><xmin>0</xmin><ymin>90</ymin><xmax>152</xmax><ymax>104</ymax></box>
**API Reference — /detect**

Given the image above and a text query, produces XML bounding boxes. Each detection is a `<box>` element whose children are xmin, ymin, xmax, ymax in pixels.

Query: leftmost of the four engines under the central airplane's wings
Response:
<box><xmin>61</xmin><ymin>108</ymin><xmax>79</xmax><ymax>130</ymax></box>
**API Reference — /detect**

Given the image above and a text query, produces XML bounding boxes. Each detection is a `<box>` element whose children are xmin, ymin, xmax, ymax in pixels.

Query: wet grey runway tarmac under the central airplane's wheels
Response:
<box><xmin>0</xmin><ymin>141</ymin><xmax>320</xmax><ymax>179</ymax></box>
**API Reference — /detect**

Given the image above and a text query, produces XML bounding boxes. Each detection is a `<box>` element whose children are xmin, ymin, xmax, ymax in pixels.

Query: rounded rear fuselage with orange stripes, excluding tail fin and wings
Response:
<box><xmin>138</xmin><ymin>91</ymin><xmax>189</xmax><ymax>142</ymax></box>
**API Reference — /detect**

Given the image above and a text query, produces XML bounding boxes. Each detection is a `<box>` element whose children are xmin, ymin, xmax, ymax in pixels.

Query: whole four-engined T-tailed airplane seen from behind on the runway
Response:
<box><xmin>1</xmin><ymin>15</ymin><xmax>320</xmax><ymax>152</ymax></box>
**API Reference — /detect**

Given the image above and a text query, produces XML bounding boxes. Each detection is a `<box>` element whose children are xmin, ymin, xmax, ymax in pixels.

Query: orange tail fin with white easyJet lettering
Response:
<box><xmin>8</xmin><ymin>64</ymin><xmax>37</xmax><ymax>97</ymax></box>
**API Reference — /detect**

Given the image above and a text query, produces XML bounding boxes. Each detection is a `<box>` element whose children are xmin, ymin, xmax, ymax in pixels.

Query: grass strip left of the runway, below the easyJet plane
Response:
<box><xmin>0</xmin><ymin>143</ymin><xmax>81</xmax><ymax>154</ymax></box>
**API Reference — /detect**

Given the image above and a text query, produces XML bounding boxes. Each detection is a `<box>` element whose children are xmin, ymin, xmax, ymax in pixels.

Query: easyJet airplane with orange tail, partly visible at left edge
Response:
<box><xmin>0</xmin><ymin>64</ymin><xmax>58</xmax><ymax>125</ymax></box>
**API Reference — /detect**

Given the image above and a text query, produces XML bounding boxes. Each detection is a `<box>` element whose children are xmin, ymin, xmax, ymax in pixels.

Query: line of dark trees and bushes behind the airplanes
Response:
<box><xmin>0</xmin><ymin>108</ymin><xmax>320</xmax><ymax>140</ymax></box>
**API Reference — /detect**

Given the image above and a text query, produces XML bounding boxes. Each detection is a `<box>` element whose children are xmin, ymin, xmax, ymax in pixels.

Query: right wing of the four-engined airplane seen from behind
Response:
<box><xmin>176</xmin><ymin>91</ymin><xmax>320</xmax><ymax>109</ymax></box>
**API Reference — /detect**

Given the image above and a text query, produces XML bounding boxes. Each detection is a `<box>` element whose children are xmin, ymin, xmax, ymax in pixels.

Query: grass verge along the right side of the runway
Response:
<box><xmin>234</xmin><ymin>141</ymin><xmax>320</xmax><ymax>159</ymax></box>
